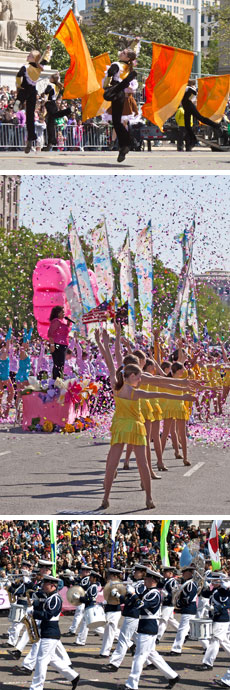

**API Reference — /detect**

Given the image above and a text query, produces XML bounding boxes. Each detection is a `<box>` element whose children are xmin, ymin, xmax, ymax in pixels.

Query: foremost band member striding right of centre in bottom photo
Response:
<box><xmin>121</xmin><ymin>568</ymin><xmax>179</xmax><ymax>690</ymax></box>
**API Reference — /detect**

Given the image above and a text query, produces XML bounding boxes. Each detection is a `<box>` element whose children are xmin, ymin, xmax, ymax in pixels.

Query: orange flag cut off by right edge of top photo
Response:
<box><xmin>197</xmin><ymin>74</ymin><xmax>230</xmax><ymax>122</ymax></box>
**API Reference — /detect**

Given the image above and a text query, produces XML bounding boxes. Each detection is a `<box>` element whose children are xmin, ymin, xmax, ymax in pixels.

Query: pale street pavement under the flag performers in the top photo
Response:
<box><xmin>0</xmin><ymin>143</ymin><xmax>230</xmax><ymax>173</ymax></box>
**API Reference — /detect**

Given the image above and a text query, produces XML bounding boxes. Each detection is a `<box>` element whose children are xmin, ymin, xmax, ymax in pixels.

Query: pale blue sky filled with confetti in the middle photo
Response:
<box><xmin>20</xmin><ymin>174</ymin><xmax>230</xmax><ymax>273</ymax></box>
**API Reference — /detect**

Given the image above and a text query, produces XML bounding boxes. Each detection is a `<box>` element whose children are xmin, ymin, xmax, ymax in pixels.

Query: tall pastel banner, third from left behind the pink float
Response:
<box><xmin>118</xmin><ymin>232</ymin><xmax>135</xmax><ymax>342</ymax></box>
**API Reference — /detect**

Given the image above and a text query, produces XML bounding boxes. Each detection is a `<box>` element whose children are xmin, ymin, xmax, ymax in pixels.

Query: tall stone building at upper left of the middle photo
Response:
<box><xmin>0</xmin><ymin>175</ymin><xmax>21</xmax><ymax>230</ymax></box>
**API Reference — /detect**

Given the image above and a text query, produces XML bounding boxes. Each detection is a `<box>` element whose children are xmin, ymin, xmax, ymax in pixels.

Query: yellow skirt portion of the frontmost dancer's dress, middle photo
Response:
<box><xmin>111</xmin><ymin>416</ymin><xmax>147</xmax><ymax>446</ymax></box>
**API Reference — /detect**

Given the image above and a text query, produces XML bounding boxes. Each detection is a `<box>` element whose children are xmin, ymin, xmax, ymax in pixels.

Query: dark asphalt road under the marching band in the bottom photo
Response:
<box><xmin>0</xmin><ymin>615</ymin><xmax>229</xmax><ymax>690</ymax></box>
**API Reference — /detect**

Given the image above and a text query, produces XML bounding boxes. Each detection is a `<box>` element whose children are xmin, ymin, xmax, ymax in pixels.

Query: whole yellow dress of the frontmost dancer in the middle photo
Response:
<box><xmin>111</xmin><ymin>389</ymin><xmax>147</xmax><ymax>446</ymax></box>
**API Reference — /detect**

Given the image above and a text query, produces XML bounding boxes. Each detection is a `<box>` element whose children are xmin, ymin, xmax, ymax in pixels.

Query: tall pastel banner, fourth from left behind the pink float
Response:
<box><xmin>135</xmin><ymin>220</ymin><xmax>153</xmax><ymax>339</ymax></box>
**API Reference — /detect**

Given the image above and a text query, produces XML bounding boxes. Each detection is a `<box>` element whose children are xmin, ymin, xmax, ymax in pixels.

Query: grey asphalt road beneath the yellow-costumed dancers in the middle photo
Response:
<box><xmin>0</xmin><ymin>418</ymin><xmax>230</xmax><ymax>517</ymax></box>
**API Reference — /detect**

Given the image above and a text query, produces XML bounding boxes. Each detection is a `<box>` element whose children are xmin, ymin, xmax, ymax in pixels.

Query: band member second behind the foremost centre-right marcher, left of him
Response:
<box><xmin>100</xmin><ymin>568</ymin><xmax>123</xmax><ymax>657</ymax></box>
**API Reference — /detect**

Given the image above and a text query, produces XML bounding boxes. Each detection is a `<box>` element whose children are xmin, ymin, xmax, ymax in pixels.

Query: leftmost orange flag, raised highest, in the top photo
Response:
<box><xmin>55</xmin><ymin>10</ymin><xmax>100</xmax><ymax>98</ymax></box>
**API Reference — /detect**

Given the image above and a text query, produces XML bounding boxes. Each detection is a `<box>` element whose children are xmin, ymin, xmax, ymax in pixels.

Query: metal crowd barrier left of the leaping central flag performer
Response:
<box><xmin>0</xmin><ymin>122</ymin><xmax>112</xmax><ymax>151</ymax></box>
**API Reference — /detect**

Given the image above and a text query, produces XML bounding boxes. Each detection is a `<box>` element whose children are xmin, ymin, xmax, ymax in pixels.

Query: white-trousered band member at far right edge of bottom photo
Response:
<box><xmin>201</xmin><ymin>572</ymin><xmax>230</xmax><ymax>671</ymax></box>
